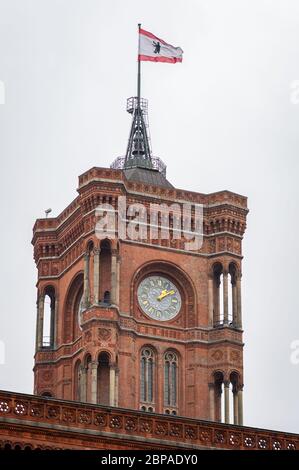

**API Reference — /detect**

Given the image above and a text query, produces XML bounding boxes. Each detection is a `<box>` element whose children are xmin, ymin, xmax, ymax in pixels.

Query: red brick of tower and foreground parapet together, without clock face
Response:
<box><xmin>0</xmin><ymin>163</ymin><xmax>299</xmax><ymax>451</ymax></box>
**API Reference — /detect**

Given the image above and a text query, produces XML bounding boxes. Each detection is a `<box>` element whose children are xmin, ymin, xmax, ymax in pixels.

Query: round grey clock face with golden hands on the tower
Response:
<box><xmin>137</xmin><ymin>276</ymin><xmax>182</xmax><ymax>321</ymax></box>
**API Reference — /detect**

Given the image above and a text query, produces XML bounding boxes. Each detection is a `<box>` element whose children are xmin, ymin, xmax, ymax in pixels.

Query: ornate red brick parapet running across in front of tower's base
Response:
<box><xmin>0</xmin><ymin>391</ymin><xmax>299</xmax><ymax>450</ymax></box>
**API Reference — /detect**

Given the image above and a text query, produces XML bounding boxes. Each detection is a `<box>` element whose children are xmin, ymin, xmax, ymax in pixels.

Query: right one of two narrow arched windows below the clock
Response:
<box><xmin>164</xmin><ymin>351</ymin><xmax>178</xmax><ymax>407</ymax></box>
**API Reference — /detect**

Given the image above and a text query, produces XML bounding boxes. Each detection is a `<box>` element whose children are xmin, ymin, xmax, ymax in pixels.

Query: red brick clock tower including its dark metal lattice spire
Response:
<box><xmin>32</xmin><ymin>98</ymin><xmax>248</xmax><ymax>424</ymax></box>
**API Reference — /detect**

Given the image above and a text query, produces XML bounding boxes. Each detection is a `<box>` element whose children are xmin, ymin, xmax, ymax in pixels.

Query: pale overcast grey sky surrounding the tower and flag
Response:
<box><xmin>0</xmin><ymin>0</ymin><xmax>299</xmax><ymax>432</ymax></box>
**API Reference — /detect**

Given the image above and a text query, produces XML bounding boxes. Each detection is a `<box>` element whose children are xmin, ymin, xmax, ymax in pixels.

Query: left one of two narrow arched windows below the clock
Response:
<box><xmin>140</xmin><ymin>347</ymin><xmax>154</xmax><ymax>403</ymax></box>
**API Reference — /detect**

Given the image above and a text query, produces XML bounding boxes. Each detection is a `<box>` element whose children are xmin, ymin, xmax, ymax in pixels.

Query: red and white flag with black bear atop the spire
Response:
<box><xmin>138</xmin><ymin>29</ymin><xmax>183</xmax><ymax>64</ymax></box>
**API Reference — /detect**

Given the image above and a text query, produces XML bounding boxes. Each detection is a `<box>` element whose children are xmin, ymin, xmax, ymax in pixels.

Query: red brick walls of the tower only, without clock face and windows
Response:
<box><xmin>33</xmin><ymin>168</ymin><xmax>247</xmax><ymax>424</ymax></box>
